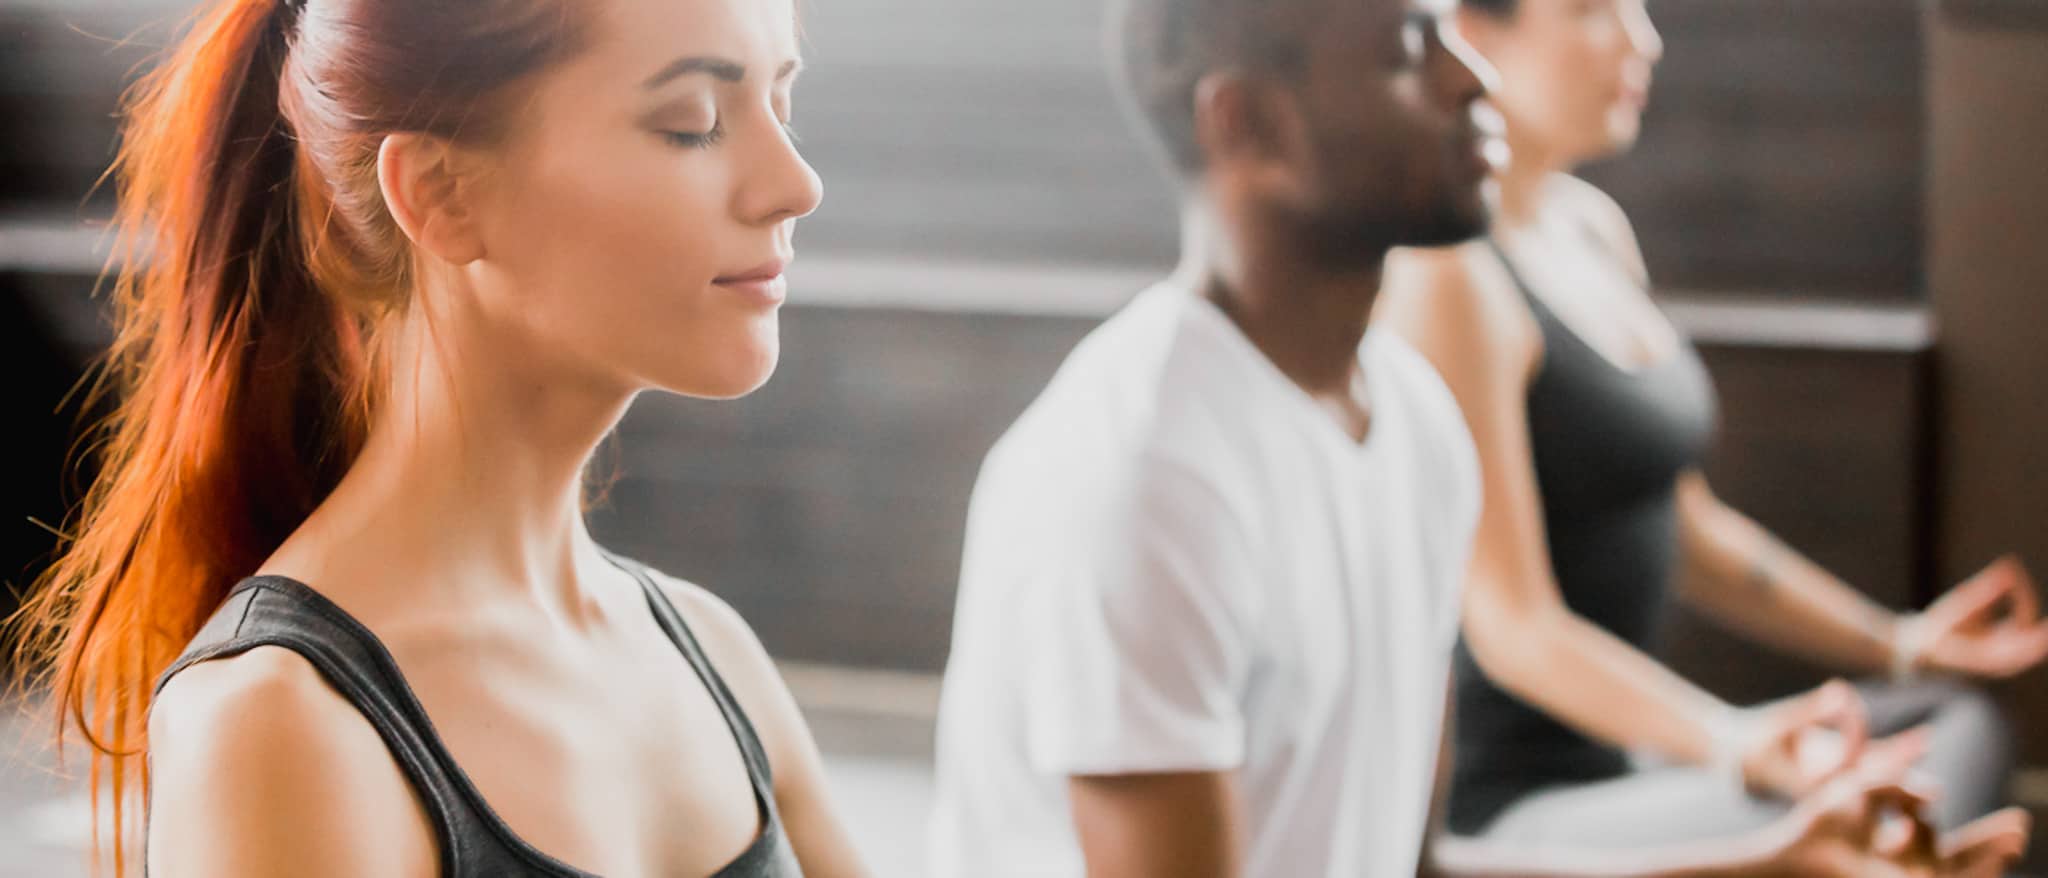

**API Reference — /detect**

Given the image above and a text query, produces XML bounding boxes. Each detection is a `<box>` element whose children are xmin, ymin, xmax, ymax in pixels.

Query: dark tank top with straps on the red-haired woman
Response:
<box><xmin>156</xmin><ymin>559</ymin><xmax>803</xmax><ymax>878</ymax></box>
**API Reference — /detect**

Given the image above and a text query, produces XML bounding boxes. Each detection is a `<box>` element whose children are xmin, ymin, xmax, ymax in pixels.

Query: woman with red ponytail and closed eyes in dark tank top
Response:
<box><xmin>6</xmin><ymin>0</ymin><xmax>862</xmax><ymax>878</ymax></box>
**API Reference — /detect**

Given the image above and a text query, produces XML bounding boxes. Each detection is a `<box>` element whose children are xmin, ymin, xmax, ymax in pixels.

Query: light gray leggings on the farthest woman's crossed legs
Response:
<box><xmin>1481</xmin><ymin>684</ymin><xmax>2013</xmax><ymax>847</ymax></box>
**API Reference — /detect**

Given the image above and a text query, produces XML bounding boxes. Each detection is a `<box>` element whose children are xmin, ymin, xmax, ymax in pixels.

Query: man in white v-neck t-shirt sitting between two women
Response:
<box><xmin>930</xmin><ymin>0</ymin><xmax>1982</xmax><ymax>878</ymax></box>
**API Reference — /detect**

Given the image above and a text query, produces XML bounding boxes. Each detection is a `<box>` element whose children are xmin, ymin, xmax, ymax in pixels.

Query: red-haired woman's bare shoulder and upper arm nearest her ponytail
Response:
<box><xmin>147</xmin><ymin>647</ymin><xmax>436</xmax><ymax>878</ymax></box>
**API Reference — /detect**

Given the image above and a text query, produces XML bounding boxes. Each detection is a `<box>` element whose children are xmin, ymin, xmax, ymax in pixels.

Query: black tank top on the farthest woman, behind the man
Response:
<box><xmin>1446</xmin><ymin>239</ymin><xmax>1716</xmax><ymax>835</ymax></box>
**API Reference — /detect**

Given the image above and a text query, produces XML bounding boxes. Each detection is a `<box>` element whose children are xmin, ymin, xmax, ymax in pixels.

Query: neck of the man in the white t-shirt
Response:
<box><xmin>1176</xmin><ymin>199</ymin><xmax>1384</xmax><ymax>397</ymax></box>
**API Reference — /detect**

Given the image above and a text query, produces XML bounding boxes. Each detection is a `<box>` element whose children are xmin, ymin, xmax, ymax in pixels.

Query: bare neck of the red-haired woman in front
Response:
<box><xmin>281</xmin><ymin>284</ymin><xmax>633</xmax><ymax>618</ymax></box>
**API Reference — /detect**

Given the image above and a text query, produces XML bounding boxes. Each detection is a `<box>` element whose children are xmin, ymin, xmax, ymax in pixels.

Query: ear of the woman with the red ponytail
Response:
<box><xmin>377</xmin><ymin>133</ymin><xmax>483</xmax><ymax>266</ymax></box>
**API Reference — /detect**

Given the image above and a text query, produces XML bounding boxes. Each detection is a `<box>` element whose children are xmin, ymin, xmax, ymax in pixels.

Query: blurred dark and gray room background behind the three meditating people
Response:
<box><xmin>0</xmin><ymin>0</ymin><xmax>2048</xmax><ymax>878</ymax></box>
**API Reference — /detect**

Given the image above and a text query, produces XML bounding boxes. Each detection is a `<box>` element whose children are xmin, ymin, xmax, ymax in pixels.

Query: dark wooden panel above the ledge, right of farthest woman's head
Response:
<box><xmin>1589</xmin><ymin>0</ymin><xmax>1923</xmax><ymax>299</ymax></box>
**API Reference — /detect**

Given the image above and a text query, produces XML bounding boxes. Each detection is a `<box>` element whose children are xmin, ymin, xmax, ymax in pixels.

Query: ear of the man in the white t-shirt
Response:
<box><xmin>1194</xmin><ymin>72</ymin><xmax>1315</xmax><ymax>188</ymax></box>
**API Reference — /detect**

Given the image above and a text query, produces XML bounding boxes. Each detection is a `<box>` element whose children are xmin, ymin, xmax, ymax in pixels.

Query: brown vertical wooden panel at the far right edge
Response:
<box><xmin>1927</xmin><ymin>0</ymin><xmax>2048</xmax><ymax>847</ymax></box>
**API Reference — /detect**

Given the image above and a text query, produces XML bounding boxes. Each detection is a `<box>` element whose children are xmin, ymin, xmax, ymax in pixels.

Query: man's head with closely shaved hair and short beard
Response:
<box><xmin>1112</xmin><ymin>0</ymin><xmax>1491</xmax><ymax>266</ymax></box>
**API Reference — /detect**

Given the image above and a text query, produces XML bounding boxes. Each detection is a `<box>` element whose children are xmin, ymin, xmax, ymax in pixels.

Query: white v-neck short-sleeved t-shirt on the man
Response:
<box><xmin>930</xmin><ymin>284</ymin><xmax>1479</xmax><ymax>878</ymax></box>
